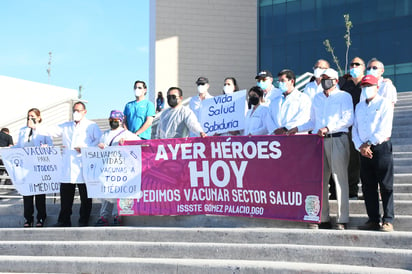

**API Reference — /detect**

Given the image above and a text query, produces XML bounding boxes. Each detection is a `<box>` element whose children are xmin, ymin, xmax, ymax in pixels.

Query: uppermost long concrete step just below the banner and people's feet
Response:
<box><xmin>0</xmin><ymin>227</ymin><xmax>412</xmax><ymax>248</ymax></box>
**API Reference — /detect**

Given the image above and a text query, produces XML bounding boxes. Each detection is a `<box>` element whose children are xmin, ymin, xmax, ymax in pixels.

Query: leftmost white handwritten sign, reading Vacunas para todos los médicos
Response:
<box><xmin>0</xmin><ymin>147</ymin><xmax>62</xmax><ymax>195</ymax></box>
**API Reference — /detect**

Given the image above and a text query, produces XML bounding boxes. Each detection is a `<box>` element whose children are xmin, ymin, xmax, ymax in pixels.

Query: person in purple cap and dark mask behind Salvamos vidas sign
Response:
<box><xmin>95</xmin><ymin>110</ymin><xmax>140</xmax><ymax>226</ymax></box>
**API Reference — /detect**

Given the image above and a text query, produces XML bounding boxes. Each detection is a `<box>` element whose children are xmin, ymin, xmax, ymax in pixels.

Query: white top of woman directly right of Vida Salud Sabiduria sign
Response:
<box><xmin>243</xmin><ymin>105</ymin><xmax>269</xmax><ymax>135</ymax></box>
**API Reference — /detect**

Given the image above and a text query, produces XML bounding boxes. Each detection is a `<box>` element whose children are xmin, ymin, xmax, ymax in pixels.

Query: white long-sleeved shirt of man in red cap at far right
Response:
<box><xmin>352</xmin><ymin>94</ymin><xmax>393</xmax><ymax>150</ymax></box>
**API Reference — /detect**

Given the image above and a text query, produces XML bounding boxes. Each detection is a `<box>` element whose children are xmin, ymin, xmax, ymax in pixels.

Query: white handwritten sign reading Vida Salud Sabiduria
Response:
<box><xmin>200</xmin><ymin>90</ymin><xmax>246</xmax><ymax>135</ymax></box>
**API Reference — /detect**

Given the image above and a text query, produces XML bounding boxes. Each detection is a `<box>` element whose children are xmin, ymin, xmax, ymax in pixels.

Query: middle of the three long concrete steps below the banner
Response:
<box><xmin>0</xmin><ymin>241</ymin><xmax>412</xmax><ymax>269</ymax></box>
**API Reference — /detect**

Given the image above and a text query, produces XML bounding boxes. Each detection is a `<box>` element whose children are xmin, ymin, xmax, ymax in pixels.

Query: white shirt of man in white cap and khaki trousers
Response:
<box><xmin>298</xmin><ymin>88</ymin><xmax>353</xmax><ymax>134</ymax></box>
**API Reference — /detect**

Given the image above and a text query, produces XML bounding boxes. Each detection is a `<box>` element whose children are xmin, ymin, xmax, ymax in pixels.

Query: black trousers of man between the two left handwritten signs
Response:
<box><xmin>58</xmin><ymin>183</ymin><xmax>92</xmax><ymax>225</ymax></box>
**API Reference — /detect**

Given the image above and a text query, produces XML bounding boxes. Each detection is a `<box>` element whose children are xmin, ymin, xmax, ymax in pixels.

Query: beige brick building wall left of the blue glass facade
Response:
<box><xmin>152</xmin><ymin>0</ymin><xmax>258</xmax><ymax>98</ymax></box>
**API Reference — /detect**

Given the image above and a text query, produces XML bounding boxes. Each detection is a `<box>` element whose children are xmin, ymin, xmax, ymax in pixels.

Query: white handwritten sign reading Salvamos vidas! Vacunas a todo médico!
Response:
<box><xmin>82</xmin><ymin>146</ymin><xmax>142</xmax><ymax>198</ymax></box>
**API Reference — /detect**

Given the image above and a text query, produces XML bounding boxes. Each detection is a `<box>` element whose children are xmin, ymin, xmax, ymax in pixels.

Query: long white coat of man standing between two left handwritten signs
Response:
<box><xmin>37</xmin><ymin>117</ymin><xmax>102</xmax><ymax>184</ymax></box>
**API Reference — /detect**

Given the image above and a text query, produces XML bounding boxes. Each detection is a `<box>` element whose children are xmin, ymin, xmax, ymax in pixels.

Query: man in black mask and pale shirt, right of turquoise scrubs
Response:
<box><xmin>156</xmin><ymin>87</ymin><xmax>206</xmax><ymax>139</ymax></box>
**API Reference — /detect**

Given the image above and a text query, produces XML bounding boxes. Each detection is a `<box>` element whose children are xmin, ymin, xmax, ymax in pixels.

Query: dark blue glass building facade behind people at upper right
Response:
<box><xmin>258</xmin><ymin>0</ymin><xmax>412</xmax><ymax>92</ymax></box>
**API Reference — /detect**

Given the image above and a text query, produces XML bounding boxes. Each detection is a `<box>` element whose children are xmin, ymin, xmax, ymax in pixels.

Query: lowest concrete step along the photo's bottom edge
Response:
<box><xmin>0</xmin><ymin>256</ymin><xmax>410</xmax><ymax>274</ymax></box>
